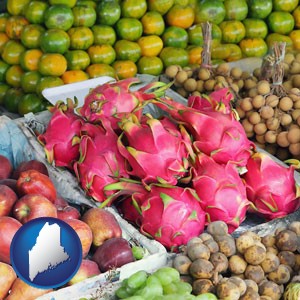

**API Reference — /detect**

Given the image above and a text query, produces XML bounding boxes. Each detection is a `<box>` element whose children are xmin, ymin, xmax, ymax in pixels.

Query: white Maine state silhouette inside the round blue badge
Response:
<box><xmin>28</xmin><ymin>222</ymin><xmax>69</xmax><ymax>281</ymax></box>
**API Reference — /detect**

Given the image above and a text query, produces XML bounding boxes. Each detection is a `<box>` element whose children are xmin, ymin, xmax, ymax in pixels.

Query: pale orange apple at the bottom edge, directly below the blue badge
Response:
<box><xmin>5</xmin><ymin>277</ymin><xmax>52</xmax><ymax>300</ymax></box>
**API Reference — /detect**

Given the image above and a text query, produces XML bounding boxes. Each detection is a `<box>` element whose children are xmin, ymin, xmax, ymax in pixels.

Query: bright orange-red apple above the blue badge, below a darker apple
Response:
<box><xmin>17</xmin><ymin>170</ymin><xmax>57</xmax><ymax>203</ymax></box>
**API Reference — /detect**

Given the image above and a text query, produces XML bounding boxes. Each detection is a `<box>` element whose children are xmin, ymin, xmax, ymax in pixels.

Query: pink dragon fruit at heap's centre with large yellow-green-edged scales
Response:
<box><xmin>118</xmin><ymin>115</ymin><xmax>191</xmax><ymax>185</ymax></box>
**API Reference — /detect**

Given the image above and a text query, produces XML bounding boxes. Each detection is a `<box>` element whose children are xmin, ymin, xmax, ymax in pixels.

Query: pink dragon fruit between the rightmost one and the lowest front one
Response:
<box><xmin>192</xmin><ymin>154</ymin><xmax>250</xmax><ymax>232</ymax></box>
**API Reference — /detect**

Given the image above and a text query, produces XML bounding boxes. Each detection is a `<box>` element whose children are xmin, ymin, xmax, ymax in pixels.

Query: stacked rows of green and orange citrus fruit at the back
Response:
<box><xmin>0</xmin><ymin>0</ymin><xmax>300</xmax><ymax>115</ymax></box>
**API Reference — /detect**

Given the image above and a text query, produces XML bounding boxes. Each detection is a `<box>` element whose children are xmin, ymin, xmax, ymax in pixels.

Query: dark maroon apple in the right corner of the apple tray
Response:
<box><xmin>92</xmin><ymin>237</ymin><xmax>135</xmax><ymax>272</ymax></box>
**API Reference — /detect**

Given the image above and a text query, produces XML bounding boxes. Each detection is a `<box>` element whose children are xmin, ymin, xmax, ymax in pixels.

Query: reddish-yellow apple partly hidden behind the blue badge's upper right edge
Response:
<box><xmin>64</xmin><ymin>219</ymin><xmax>93</xmax><ymax>258</ymax></box>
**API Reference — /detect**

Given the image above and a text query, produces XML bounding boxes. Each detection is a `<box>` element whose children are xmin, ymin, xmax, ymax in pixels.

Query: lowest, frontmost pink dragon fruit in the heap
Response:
<box><xmin>136</xmin><ymin>185</ymin><xmax>205</xmax><ymax>251</ymax></box>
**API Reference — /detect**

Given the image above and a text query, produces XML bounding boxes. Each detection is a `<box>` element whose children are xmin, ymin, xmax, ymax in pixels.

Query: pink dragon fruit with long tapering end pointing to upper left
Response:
<box><xmin>153</xmin><ymin>92</ymin><xmax>255</xmax><ymax>167</ymax></box>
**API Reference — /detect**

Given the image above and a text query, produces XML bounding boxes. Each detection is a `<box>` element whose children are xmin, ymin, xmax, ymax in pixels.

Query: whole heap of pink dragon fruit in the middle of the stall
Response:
<box><xmin>38</xmin><ymin>78</ymin><xmax>300</xmax><ymax>251</ymax></box>
